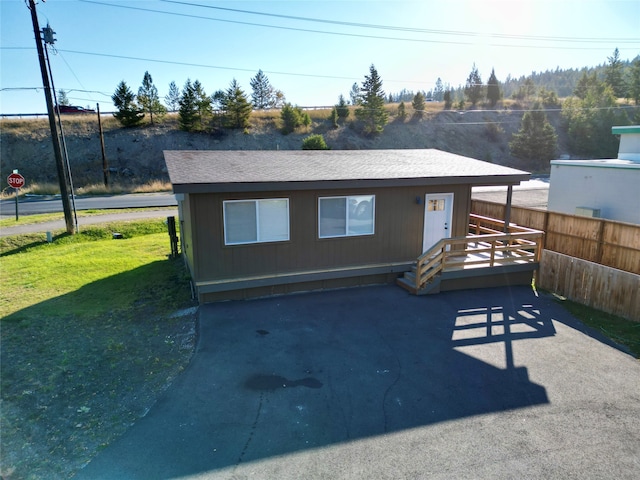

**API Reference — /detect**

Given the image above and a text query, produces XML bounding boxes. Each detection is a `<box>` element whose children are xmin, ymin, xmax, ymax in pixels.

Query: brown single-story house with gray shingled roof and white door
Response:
<box><xmin>164</xmin><ymin>149</ymin><xmax>530</xmax><ymax>302</ymax></box>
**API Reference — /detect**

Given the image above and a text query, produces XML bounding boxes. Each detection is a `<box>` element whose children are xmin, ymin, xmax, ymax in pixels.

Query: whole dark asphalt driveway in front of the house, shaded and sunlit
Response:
<box><xmin>77</xmin><ymin>286</ymin><xmax>640</xmax><ymax>479</ymax></box>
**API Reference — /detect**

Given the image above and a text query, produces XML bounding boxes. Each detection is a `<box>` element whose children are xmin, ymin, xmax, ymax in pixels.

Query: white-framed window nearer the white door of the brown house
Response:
<box><xmin>318</xmin><ymin>195</ymin><xmax>376</xmax><ymax>238</ymax></box>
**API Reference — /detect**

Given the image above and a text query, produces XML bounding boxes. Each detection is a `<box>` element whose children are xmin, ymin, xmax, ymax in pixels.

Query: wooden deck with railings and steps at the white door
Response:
<box><xmin>398</xmin><ymin>214</ymin><xmax>544</xmax><ymax>294</ymax></box>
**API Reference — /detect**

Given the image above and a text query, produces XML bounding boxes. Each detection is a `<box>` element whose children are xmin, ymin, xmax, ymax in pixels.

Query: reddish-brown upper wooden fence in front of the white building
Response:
<box><xmin>471</xmin><ymin>200</ymin><xmax>640</xmax><ymax>274</ymax></box>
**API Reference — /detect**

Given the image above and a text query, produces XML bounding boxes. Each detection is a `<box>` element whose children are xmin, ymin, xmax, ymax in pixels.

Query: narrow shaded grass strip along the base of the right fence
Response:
<box><xmin>561</xmin><ymin>300</ymin><xmax>640</xmax><ymax>358</ymax></box>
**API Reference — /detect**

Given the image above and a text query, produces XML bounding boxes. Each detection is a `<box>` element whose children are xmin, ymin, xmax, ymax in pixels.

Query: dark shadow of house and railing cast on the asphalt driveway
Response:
<box><xmin>78</xmin><ymin>286</ymin><xmax>555</xmax><ymax>479</ymax></box>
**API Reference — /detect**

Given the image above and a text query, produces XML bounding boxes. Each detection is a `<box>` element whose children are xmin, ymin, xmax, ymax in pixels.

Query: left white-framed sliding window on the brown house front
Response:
<box><xmin>222</xmin><ymin>198</ymin><xmax>289</xmax><ymax>245</ymax></box>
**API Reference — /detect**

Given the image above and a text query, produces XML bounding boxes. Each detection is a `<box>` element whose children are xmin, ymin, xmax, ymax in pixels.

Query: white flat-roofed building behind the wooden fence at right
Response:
<box><xmin>548</xmin><ymin>125</ymin><xmax>640</xmax><ymax>224</ymax></box>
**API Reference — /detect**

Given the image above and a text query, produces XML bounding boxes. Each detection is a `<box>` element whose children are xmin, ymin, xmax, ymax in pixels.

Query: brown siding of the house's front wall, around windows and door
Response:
<box><xmin>190</xmin><ymin>185</ymin><xmax>470</xmax><ymax>282</ymax></box>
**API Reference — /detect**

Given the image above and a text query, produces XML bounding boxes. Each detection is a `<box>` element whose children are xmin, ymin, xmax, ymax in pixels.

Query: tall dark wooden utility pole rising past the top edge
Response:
<box><xmin>29</xmin><ymin>0</ymin><xmax>76</xmax><ymax>235</ymax></box>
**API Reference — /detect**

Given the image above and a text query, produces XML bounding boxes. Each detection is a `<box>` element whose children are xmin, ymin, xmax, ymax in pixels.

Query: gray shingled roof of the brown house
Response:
<box><xmin>164</xmin><ymin>149</ymin><xmax>529</xmax><ymax>193</ymax></box>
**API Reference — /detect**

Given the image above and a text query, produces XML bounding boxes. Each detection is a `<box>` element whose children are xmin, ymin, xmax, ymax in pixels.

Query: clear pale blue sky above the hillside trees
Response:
<box><xmin>0</xmin><ymin>0</ymin><xmax>640</xmax><ymax>113</ymax></box>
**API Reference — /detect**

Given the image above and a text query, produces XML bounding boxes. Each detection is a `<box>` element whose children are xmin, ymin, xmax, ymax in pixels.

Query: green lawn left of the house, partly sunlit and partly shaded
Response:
<box><xmin>0</xmin><ymin>220</ymin><xmax>194</xmax><ymax>478</ymax></box>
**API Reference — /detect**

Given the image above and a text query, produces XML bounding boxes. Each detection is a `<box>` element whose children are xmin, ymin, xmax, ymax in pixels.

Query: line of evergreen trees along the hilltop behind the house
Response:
<box><xmin>107</xmin><ymin>49</ymin><xmax>640</xmax><ymax>159</ymax></box>
